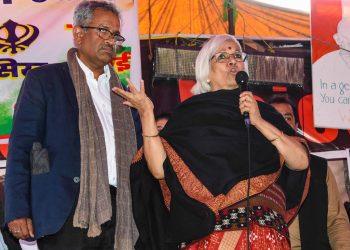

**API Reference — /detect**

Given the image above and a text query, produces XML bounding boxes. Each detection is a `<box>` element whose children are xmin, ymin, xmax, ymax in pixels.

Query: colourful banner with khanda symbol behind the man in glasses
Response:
<box><xmin>0</xmin><ymin>0</ymin><xmax>141</xmax><ymax>155</ymax></box>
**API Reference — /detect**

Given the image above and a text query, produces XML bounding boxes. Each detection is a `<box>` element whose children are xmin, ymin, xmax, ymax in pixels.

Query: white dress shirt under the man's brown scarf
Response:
<box><xmin>77</xmin><ymin>56</ymin><xmax>117</xmax><ymax>187</ymax></box>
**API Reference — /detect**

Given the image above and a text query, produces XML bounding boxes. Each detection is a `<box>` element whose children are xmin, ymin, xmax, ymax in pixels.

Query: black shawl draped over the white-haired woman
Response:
<box><xmin>131</xmin><ymin>90</ymin><xmax>306</xmax><ymax>249</ymax></box>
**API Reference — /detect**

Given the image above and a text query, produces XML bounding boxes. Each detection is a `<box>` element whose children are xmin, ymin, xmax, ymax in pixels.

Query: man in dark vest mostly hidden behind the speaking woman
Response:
<box><xmin>269</xmin><ymin>96</ymin><xmax>350</xmax><ymax>250</ymax></box>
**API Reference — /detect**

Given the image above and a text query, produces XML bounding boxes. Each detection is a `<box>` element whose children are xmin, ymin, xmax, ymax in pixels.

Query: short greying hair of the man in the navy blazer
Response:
<box><xmin>73</xmin><ymin>1</ymin><xmax>120</xmax><ymax>26</ymax></box>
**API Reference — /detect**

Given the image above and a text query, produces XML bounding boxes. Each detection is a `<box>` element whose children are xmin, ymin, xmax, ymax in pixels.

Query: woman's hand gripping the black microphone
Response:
<box><xmin>239</xmin><ymin>91</ymin><xmax>262</xmax><ymax>126</ymax></box>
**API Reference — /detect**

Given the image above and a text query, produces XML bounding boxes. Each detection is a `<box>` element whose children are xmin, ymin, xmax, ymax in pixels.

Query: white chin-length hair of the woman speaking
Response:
<box><xmin>191</xmin><ymin>34</ymin><xmax>248</xmax><ymax>95</ymax></box>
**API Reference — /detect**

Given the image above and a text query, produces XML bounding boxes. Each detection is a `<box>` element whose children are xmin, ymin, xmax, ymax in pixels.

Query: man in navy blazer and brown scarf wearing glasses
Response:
<box><xmin>5</xmin><ymin>1</ymin><xmax>140</xmax><ymax>250</ymax></box>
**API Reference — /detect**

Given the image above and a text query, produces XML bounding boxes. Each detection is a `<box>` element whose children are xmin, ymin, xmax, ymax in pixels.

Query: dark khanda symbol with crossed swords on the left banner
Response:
<box><xmin>0</xmin><ymin>19</ymin><xmax>39</xmax><ymax>55</ymax></box>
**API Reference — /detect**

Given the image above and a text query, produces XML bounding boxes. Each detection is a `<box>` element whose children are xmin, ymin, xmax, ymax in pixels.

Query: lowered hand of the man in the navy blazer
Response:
<box><xmin>8</xmin><ymin>218</ymin><xmax>34</xmax><ymax>240</ymax></box>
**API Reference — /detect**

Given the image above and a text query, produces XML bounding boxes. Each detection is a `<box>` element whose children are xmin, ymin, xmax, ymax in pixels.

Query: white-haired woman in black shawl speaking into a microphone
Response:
<box><xmin>114</xmin><ymin>35</ymin><xmax>309</xmax><ymax>249</ymax></box>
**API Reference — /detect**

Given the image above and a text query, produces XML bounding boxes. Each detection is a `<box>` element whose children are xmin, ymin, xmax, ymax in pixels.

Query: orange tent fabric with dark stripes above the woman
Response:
<box><xmin>138</xmin><ymin>0</ymin><xmax>310</xmax><ymax>39</ymax></box>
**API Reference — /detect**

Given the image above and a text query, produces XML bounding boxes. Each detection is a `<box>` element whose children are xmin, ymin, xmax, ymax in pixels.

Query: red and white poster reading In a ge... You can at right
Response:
<box><xmin>311</xmin><ymin>0</ymin><xmax>350</xmax><ymax>129</ymax></box>
